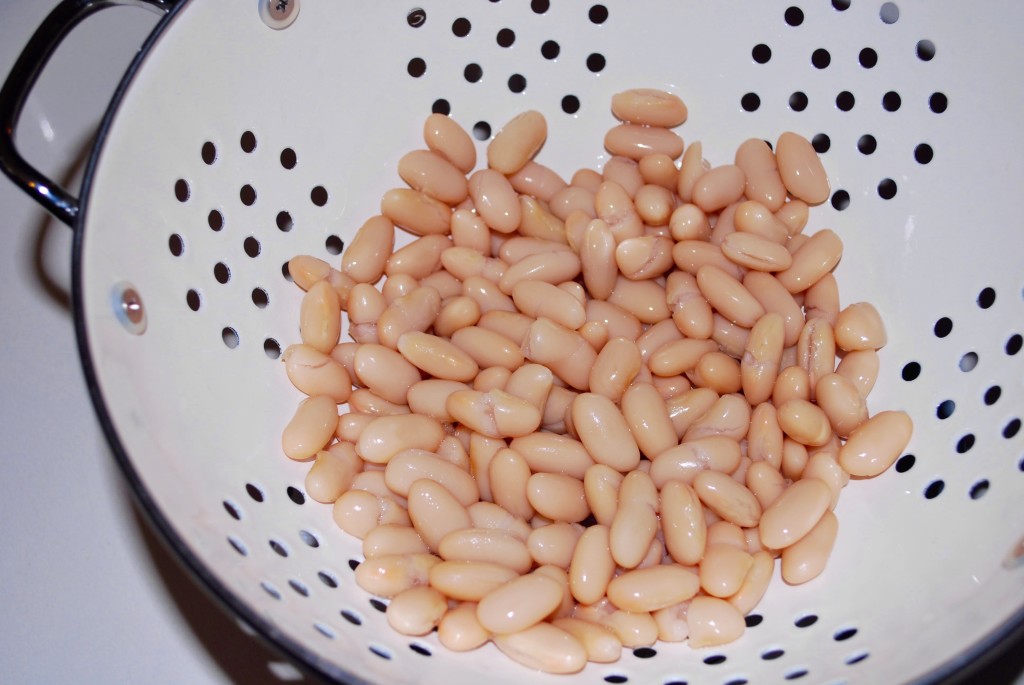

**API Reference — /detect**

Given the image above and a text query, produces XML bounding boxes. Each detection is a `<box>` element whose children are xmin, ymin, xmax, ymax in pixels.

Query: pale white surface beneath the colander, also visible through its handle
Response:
<box><xmin>0</xmin><ymin>0</ymin><xmax>1024</xmax><ymax>685</ymax></box>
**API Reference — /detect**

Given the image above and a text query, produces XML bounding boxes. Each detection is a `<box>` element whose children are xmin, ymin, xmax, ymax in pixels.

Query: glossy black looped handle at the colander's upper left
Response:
<box><xmin>0</xmin><ymin>0</ymin><xmax>179</xmax><ymax>226</ymax></box>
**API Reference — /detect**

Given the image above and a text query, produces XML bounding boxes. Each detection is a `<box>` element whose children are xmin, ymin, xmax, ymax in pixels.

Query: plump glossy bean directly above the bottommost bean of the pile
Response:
<box><xmin>476</xmin><ymin>573</ymin><xmax>562</xmax><ymax>635</ymax></box>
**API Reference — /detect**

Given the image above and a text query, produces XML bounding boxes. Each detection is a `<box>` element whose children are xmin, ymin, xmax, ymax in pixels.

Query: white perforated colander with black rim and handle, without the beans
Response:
<box><xmin>0</xmin><ymin>0</ymin><xmax>1024</xmax><ymax>685</ymax></box>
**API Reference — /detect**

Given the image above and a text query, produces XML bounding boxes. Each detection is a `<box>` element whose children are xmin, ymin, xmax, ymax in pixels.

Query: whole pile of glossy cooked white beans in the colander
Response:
<box><xmin>283</xmin><ymin>89</ymin><xmax>911</xmax><ymax>673</ymax></box>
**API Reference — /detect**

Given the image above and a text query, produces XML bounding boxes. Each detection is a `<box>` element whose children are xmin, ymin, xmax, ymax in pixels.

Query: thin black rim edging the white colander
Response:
<box><xmin>72</xmin><ymin>0</ymin><xmax>1024</xmax><ymax>685</ymax></box>
